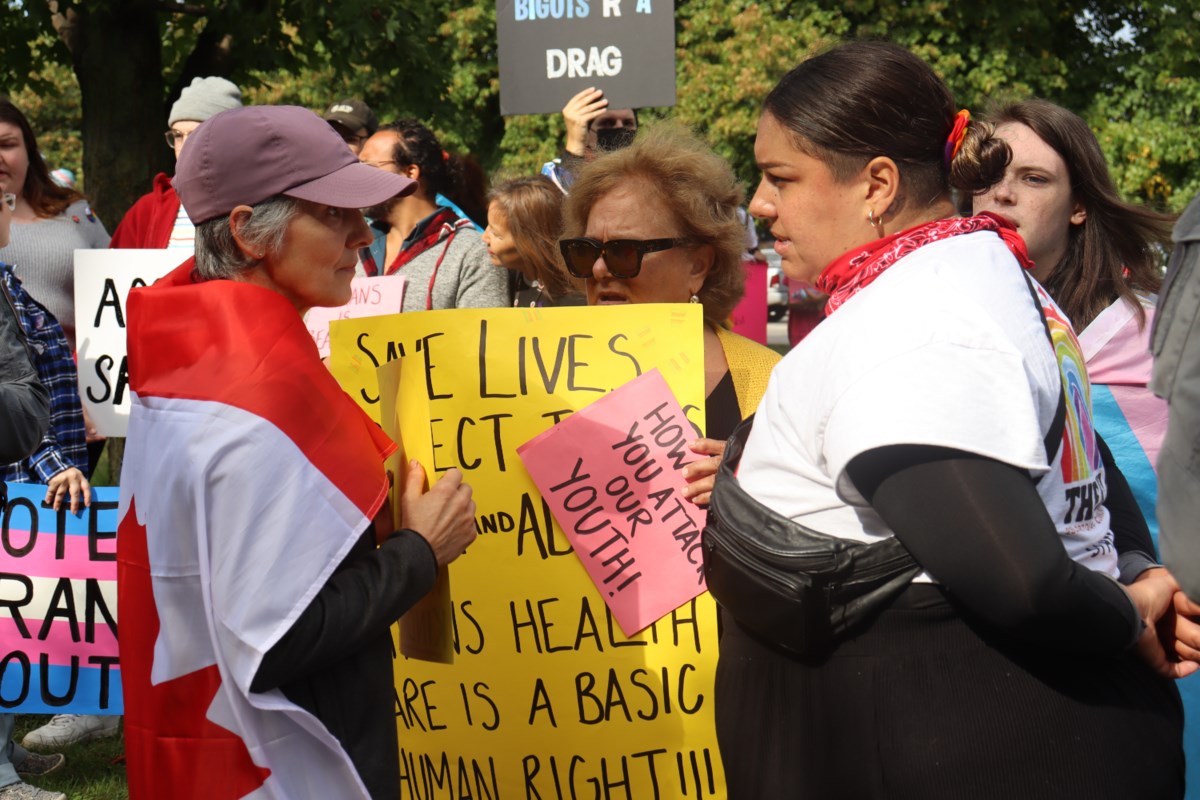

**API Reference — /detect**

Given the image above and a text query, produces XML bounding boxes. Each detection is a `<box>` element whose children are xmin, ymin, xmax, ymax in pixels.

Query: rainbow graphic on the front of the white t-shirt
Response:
<box><xmin>1037</xmin><ymin>287</ymin><xmax>1103</xmax><ymax>486</ymax></box>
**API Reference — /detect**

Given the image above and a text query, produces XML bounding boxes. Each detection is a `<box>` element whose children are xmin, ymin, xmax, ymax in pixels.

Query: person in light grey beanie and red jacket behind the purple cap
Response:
<box><xmin>110</xmin><ymin>77</ymin><xmax>241</xmax><ymax>251</ymax></box>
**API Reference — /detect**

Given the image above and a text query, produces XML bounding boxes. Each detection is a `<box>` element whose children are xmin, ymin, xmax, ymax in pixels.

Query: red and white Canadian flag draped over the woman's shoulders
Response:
<box><xmin>118</xmin><ymin>260</ymin><xmax>395</xmax><ymax>799</ymax></box>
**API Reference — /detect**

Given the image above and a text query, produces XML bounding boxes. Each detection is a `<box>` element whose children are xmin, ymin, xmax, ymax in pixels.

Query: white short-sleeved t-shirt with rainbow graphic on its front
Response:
<box><xmin>738</xmin><ymin>231</ymin><xmax>1117</xmax><ymax>581</ymax></box>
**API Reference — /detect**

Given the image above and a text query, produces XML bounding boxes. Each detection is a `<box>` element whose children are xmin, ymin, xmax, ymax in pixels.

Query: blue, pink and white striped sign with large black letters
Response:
<box><xmin>0</xmin><ymin>483</ymin><xmax>122</xmax><ymax>714</ymax></box>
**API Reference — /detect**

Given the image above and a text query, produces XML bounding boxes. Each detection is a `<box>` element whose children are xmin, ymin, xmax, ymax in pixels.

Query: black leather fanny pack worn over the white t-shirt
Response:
<box><xmin>702</xmin><ymin>417</ymin><xmax>922</xmax><ymax>655</ymax></box>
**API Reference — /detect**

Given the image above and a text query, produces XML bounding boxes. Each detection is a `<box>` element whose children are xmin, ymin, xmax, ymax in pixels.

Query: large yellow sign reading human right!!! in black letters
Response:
<box><xmin>330</xmin><ymin>305</ymin><xmax>725</xmax><ymax>800</ymax></box>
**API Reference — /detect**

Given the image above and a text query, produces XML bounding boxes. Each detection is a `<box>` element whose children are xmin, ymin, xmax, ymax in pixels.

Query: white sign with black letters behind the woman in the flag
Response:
<box><xmin>74</xmin><ymin>249</ymin><xmax>188</xmax><ymax>437</ymax></box>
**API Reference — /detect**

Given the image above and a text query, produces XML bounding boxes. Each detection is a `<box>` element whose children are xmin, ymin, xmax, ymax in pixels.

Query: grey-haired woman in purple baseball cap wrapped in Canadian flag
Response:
<box><xmin>118</xmin><ymin>107</ymin><xmax>475</xmax><ymax>799</ymax></box>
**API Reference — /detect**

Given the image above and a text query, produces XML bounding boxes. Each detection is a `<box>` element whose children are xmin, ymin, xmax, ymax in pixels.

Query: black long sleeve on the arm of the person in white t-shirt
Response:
<box><xmin>847</xmin><ymin>445</ymin><xmax>1141</xmax><ymax>654</ymax></box>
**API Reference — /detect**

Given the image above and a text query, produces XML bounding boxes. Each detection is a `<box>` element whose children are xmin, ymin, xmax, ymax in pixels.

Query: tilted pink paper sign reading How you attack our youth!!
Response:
<box><xmin>517</xmin><ymin>369</ymin><xmax>704</xmax><ymax>636</ymax></box>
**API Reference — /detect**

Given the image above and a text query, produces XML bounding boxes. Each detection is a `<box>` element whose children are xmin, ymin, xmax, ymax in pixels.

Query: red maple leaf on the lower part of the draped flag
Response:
<box><xmin>116</xmin><ymin>499</ymin><xmax>271</xmax><ymax>800</ymax></box>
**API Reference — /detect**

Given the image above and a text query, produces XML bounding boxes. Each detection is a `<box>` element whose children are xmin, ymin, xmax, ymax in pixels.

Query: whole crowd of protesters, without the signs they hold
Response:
<box><xmin>0</xmin><ymin>42</ymin><xmax>1200</xmax><ymax>800</ymax></box>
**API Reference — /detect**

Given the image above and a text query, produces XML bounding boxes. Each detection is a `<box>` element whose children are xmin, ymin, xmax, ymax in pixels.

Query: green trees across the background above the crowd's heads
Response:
<box><xmin>7</xmin><ymin>0</ymin><xmax>1200</xmax><ymax>224</ymax></box>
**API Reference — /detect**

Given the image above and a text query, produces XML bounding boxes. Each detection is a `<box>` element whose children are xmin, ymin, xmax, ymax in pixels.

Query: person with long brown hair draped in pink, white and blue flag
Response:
<box><xmin>973</xmin><ymin>100</ymin><xmax>1200</xmax><ymax>796</ymax></box>
